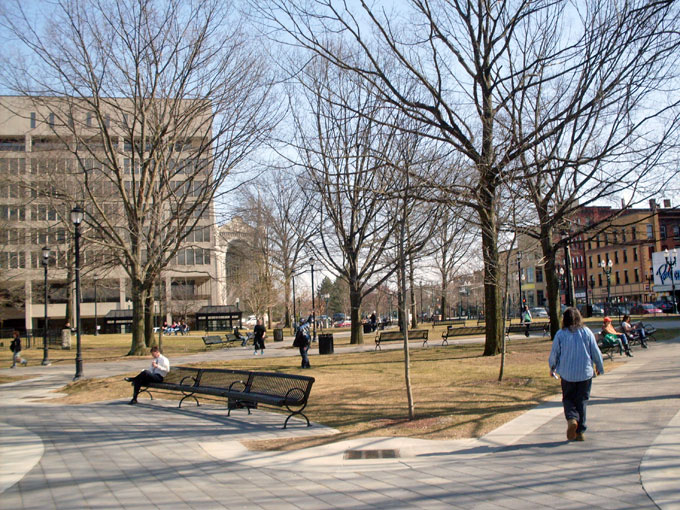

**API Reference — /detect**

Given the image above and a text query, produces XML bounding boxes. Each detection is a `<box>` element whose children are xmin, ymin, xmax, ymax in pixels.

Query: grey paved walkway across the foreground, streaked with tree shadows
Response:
<box><xmin>0</xmin><ymin>328</ymin><xmax>680</xmax><ymax>510</ymax></box>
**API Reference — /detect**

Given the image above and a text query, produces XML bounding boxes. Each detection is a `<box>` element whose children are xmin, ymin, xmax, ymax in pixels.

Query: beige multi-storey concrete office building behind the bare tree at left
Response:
<box><xmin>0</xmin><ymin>96</ymin><xmax>223</xmax><ymax>332</ymax></box>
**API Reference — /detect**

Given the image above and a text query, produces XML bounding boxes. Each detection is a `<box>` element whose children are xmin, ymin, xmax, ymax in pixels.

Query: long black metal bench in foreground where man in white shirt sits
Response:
<box><xmin>129</xmin><ymin>367</ymin><xmax>314</xmax><ymax>429</ymax></box>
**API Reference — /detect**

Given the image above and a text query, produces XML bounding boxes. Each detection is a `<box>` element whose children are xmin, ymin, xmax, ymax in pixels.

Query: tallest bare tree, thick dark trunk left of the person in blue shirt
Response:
<box><xmin>254</xmin><ymin>0</ymin><xmax>678</xmax><ymax>355</ymax></box>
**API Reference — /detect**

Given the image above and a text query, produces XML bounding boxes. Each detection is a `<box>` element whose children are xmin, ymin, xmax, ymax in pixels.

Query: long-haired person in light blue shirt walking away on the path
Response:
<box><xmin>548</xmin><ymin>307</ymin><xmax>604</xmax><ymax>441</ymax></box>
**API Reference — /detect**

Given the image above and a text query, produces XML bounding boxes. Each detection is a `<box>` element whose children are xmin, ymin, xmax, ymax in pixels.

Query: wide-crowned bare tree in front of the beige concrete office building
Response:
<box><xmin>2</xmin><ymin>0</ymin><xmax>277</xmax><ymax>354</ymax></box>
